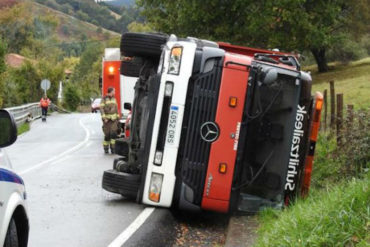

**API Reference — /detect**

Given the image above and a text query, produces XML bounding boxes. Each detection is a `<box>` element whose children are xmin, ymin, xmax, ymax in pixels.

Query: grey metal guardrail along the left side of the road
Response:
<box><xmin>5</xmin><ymin>102</ymin><xmax>41</xmax><ymax>125</ymax></box>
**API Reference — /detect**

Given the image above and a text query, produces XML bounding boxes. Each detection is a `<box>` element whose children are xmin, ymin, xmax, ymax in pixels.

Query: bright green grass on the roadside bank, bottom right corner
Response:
<box><xmin>255</xmin><ymin>174</ymin><xmax>370</xmax><ymax>247</ymax></box>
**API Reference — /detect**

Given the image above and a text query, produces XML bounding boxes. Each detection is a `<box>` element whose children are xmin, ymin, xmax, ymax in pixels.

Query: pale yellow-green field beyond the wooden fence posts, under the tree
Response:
<box><xmin>305</xmin><ymin>57</ymin><xmax>370</xmax><ymax>109</ymax></box>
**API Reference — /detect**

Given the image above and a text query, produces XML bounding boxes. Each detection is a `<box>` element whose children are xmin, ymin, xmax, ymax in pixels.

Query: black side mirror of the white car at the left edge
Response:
<box><xmin>0</xmin><ymin>110</ymin><xmax>17</xmax><ymax>148</ymax></box>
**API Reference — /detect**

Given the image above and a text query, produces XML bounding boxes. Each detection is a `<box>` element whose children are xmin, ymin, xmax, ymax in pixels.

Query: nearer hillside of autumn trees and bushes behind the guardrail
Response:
<box><xmin>0</xmin><ymin>1</ymin><xmax>120</xmax><ymax>109</ymax></box>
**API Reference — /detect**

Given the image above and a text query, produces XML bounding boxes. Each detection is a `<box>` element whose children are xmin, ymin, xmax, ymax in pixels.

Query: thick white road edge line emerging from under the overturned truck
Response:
<box><xmin>108</xmin><ymin>207</ymin><xmax>155</xmax><ymax>247</ymax></box>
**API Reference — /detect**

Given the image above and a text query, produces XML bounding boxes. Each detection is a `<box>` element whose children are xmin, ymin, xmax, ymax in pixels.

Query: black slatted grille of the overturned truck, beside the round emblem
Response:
<box><xmin>178</xmin><ymin>59</ymin><xmax>222</xmax><ymax>204</ymax></box>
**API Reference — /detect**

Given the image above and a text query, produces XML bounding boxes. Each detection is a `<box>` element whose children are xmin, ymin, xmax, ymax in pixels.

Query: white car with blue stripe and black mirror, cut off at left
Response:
<box><xmin>0</xmin><ymin>110</ymin><xmax>29</xmax><ymax>247</ymax></box>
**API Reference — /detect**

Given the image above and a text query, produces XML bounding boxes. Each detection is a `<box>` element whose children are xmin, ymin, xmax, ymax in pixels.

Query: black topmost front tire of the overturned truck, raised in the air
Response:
<box><xmin>121</xmin><ymin>33</ymin><xmax>168</xmax><ymax>59</ymax></box>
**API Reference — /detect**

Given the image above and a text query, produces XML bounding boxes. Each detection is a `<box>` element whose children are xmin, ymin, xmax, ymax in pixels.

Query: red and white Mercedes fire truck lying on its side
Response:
<box><xmin>103</xmin><ymin>33</ymin><xmax>322</xmax><ymax>212</ymax></box>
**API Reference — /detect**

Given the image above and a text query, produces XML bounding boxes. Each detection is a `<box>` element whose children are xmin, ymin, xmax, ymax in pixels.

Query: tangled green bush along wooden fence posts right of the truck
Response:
<box><xmin>312</xmin><ymin>110</ymin><xmax>370</xmax><ymax>188</ymax></box>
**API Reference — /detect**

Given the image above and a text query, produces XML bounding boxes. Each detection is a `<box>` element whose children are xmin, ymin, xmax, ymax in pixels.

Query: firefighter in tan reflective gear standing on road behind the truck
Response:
<box><xmin>100</xmin><ymin>87</ymin><xmax>119</xmax><ymax>153</ymax></box>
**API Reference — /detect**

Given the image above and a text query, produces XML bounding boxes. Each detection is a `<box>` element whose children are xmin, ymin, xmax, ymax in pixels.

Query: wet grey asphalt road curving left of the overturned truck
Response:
<box><xmin>6</xmin><ymin>114</ymin><xmax>162</xmax><ymax>247</ymax></box>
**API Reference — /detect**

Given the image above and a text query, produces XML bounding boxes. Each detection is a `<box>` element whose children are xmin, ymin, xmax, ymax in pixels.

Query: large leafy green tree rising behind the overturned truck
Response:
<box><xmin>137</xmin><ymin>0</ymin><xmax>370</xmax><ymax>72</ymax></box>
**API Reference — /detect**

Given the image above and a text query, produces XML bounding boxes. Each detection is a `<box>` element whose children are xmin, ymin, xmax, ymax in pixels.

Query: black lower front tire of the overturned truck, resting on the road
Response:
<box><xmin>102</xmin><ymin>169</ymin><xmax>141</xmax><ymax>199</ymax></box>
